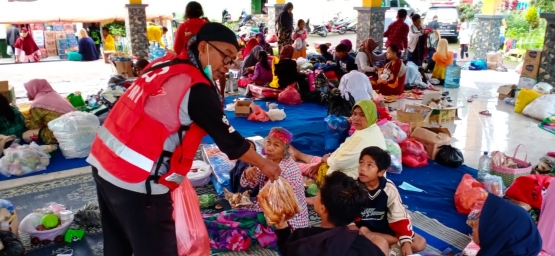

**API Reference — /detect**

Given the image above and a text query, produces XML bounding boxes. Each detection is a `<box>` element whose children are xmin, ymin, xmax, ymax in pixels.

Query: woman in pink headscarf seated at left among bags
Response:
<box><xmin>22</xmin><ymin>79</ymin><xmax>75</xmax><ymax>144</ymax></box>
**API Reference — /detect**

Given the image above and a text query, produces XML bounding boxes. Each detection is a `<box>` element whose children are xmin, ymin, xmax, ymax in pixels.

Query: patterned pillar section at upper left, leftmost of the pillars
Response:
<box><xmin>125</xmin><ymin>3</ymin><xmax>149</xmax><ymax>59</ymax></box>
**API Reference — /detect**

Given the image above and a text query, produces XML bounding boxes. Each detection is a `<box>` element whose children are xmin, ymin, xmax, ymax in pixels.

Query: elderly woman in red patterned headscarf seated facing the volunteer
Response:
<box><xmin>241</xmin><ymin>127</ymin><xmax>308</xmax><ymax>229</ymax></box>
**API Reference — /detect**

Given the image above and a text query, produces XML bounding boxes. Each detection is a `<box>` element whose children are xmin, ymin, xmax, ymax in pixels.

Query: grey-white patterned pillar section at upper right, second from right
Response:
<box><xmin>473</xmin><ymin>14</ymin><xmax>505</xmax><ymax>60</ymax></box>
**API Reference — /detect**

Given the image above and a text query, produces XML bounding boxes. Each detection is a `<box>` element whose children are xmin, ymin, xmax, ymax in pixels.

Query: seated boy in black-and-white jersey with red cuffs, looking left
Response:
<box><xmin>349</xmin><ymin>147</ymin><xmax>426</xmax><ymax>255</ymax></box>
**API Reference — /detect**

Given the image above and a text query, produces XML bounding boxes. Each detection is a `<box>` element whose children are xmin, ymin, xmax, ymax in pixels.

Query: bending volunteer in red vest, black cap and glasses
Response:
<box><xmin>87</xmin><ymin>23</ymin><xmax>281</xmax><ymax>256</ymax></box>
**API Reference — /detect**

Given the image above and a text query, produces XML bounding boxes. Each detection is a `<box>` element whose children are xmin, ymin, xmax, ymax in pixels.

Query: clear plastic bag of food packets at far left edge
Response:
<box><xmin>0</xmin><ymin>142</ymin><xmax>50</xmax><ymax>177</ymax></box>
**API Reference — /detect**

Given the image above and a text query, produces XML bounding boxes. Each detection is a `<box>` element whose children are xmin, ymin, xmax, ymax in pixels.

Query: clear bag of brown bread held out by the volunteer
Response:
<box><xmin>258</xmin><ymin>177</ymin><xmax>300</xmax><ymax>226</ymax></box>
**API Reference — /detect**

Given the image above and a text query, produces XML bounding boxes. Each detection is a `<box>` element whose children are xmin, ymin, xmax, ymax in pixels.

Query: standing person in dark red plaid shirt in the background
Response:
<box><xmin>383</xmin><ymin>9</ymin><xmax>409</xmax><ymax>58</ymax></box>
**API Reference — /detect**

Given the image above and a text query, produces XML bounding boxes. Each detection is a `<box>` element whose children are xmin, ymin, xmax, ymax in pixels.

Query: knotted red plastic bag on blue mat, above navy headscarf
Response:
<box><xmin>455</xmin><ymin>174</ymin><xmax>488</xmax><ymax>215</ymax></box>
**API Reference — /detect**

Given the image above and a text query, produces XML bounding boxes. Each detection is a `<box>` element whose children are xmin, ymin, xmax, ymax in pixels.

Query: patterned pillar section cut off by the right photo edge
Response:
<box><xmin>538</xmin><ymin>13</ymin><xmax>555</xmax><ymax>85</ymax></box>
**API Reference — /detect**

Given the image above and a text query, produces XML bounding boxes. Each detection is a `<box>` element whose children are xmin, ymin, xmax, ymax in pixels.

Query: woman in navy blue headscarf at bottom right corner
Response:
<box><xmin>467</xmin><ymin>194</ymin><xmax>542</xmax><ymax>256</ymax></box>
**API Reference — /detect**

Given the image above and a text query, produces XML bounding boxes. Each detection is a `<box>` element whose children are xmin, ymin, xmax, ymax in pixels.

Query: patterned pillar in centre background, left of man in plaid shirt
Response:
<box><xmin>355</xmin><ymin>6</ymin><xmax>389</xmax><ymax>47</ymax></box>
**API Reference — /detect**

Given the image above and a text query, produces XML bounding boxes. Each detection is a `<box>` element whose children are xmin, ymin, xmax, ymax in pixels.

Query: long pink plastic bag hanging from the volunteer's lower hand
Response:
<box><xmin>172</xmin><ymin>179</ymin><xmax>210</xmax><ymax>256</ymax></box>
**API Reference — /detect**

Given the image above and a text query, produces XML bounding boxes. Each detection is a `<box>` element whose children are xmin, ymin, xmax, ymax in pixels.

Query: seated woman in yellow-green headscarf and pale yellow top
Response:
<box><xmin>291</xmin><ymin>100</ymin><xmax>386</xmax><ymax>179</ymax></box>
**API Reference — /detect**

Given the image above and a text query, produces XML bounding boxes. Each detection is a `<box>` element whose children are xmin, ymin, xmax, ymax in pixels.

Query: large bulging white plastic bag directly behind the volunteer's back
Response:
<box><xmin>48</xmin><ymin>111</ymin><xmax>100</xmax><ymax>159</ymax></box>
